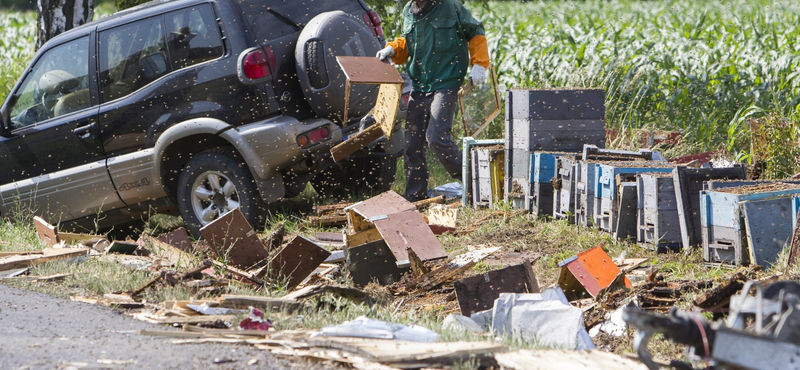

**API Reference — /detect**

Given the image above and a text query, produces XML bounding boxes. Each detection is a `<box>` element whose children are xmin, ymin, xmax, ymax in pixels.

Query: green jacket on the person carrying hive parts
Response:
<box><xmin>402</xmin><ymin>0</ymin><xmax>485</xmax><ymax>92</ymax></box>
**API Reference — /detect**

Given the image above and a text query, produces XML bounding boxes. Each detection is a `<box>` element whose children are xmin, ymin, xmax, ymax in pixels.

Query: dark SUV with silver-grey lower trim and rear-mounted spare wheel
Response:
<box><xmin>0</xmin><ymin>0</ymin><xmax>403</xmax><ymax>234</ymax></box>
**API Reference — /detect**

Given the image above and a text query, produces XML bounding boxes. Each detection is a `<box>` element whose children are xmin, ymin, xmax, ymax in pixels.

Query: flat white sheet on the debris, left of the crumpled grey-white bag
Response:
<box><xmin>312</xmin><ymin>316</ymin><xmax>439</xmax><ymax>342</ymax></box>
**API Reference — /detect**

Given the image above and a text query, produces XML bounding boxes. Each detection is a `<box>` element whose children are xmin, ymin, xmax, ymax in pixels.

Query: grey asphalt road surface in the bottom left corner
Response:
<box><xmin>0</xmin><ymin>284</ymin><xmax>306</xmax><ymax>370</ymax></box>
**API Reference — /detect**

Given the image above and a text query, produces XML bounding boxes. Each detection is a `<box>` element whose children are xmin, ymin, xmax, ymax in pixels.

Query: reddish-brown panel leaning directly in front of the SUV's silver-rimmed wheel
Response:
<box><xmin>200</xmin><ymin>208</ymin><xmax>269</xmax><ymax>270</ymax></box>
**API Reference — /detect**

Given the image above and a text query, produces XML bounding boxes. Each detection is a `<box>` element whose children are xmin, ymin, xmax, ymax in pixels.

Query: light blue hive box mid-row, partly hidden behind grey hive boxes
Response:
<box><xmin>592</xmin><ymin>161</ymin><xmax>674</xmax><ymax>232</ymax></box>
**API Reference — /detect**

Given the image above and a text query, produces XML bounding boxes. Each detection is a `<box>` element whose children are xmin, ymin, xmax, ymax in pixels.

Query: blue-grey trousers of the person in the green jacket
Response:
<box><xmin>403</xmin><ymin>87</ymin><xmax>461</xmax><ymax>200</ymax></box>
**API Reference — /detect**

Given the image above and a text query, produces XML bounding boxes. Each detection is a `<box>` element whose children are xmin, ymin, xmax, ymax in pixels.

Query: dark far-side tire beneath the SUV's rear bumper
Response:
<box><xmin>311</xmin><ymin>157</ymin><xmax>397</xmax><ymax>199</ymax></box>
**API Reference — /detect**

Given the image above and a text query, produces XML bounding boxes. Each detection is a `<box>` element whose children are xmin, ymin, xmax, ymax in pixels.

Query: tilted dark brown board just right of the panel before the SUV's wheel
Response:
<box><xmin>257</xmin><ymin>235</ymin><xmax>331</xmax><ymax>290</ymax></box>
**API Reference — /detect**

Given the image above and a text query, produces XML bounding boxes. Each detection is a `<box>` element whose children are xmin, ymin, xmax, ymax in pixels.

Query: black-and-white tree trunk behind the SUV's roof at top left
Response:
<box><xmin>36</xmin><ymin>0</ymin><xmax>94</xmax><ymax>50</ymax></box>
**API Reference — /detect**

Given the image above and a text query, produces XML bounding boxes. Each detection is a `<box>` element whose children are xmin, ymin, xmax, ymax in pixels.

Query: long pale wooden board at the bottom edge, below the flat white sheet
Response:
<box><xmin>307</xmin><ymin>337</ymin><xmax>508</xmax><ymax>367</ymax></box>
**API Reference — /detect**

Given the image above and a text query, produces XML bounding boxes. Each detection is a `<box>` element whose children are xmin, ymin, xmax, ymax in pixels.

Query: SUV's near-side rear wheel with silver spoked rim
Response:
<box><xmin>177</xmin><ymin>148</ymin><xmax>263</xmax><ymax>237</ymax></box>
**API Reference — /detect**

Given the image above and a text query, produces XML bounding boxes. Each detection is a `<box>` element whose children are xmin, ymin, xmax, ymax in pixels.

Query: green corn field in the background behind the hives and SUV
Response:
<box><xmin>0</xmin><ymin>0</ymin><xmax>800</xmax><ymax>177</ymax></box>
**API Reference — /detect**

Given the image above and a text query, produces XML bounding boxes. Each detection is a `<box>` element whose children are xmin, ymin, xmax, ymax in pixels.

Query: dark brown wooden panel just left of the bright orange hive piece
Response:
<box><xmin>453</xmin><ymin>260</ymin><xmax>539</xmax><ymax>317</ymax></box>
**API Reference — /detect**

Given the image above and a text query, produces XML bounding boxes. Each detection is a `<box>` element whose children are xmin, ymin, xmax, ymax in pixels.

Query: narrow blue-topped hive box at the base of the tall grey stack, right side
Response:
<box><xmin>529</xmin><ymin>152</ymin><xmax>568</xmax><ymax>216</ymax></box>
